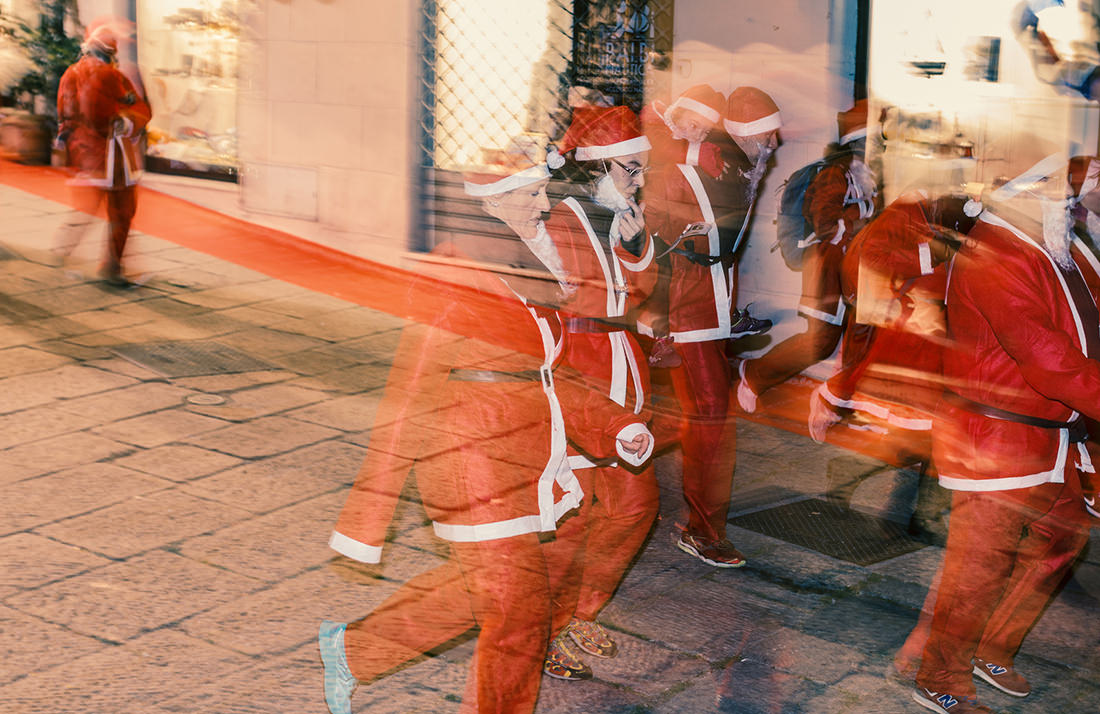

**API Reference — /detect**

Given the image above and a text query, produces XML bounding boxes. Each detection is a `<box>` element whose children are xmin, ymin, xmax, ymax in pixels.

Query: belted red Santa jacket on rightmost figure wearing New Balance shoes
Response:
<box><xmin>933</xmin><ymin>211</ymin><xmax>1100</xmax><ymax>491</ymax></box>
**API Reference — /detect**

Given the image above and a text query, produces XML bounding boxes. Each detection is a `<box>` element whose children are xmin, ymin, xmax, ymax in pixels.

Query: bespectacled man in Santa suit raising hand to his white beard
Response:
<box><xmin>536</xmin><ymin>107</ymin><xmax>658</xmax><ymax>679</ymax></box>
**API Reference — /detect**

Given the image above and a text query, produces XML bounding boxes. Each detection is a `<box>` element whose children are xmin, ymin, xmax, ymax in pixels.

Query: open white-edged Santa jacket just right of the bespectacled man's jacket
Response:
<box><xmin>640</xmin><ymin>164</ymin><xmax>744</xmax><ymax>342</ymax></box>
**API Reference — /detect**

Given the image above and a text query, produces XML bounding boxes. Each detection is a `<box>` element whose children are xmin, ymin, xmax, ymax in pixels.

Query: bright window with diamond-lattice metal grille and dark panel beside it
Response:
<box><xmin>411</xmin><ymin>0</ymin><xmax>673</xmax><ymax>255</ymax></box>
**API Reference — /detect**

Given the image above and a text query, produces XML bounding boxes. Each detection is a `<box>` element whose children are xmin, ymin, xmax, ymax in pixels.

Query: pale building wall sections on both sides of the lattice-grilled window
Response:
<box><xmin>227</xmin><ymin>0</ymin><xmax>856</xmax><ymax>290</ymax></box>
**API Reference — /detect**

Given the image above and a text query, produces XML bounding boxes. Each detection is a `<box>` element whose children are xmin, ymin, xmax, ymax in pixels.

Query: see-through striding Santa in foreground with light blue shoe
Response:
<box><xmin>319</xmin><ymin>157</ymin><xmax>652</xmax><ymax>714</ymax></box>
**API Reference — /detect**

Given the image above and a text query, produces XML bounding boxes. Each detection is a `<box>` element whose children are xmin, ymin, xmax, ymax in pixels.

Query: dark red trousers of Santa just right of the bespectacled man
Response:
<box><xmin>672</xmin><ymin>340</ymin><xmax>737</xmax><ymax>540</ymax></box>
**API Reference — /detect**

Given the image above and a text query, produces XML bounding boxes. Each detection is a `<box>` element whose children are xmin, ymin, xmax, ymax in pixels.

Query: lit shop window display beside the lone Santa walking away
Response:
<box><xmin>138</xmin><ymin>0</ymin><xmax>240</xmax><ymax>180</ymax></box>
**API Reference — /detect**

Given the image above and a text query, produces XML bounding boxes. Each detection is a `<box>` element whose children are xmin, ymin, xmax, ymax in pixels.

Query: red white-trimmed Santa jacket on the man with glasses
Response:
<box><xmin>546</xmin><ymin>198</ymin><xmax>657</xmax><ymax>421</ymax></box>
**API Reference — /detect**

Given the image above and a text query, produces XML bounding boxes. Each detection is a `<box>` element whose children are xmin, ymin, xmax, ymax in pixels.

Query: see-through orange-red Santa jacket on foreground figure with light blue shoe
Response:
<box><xmin>329</xmin><ymin>245</ymin><xmax>645</xmax><ymax>562</ymax></box>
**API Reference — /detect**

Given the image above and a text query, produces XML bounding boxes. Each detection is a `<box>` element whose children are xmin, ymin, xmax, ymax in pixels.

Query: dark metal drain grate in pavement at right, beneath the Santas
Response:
<box><xmin>729</xmin><ymin>498</ymin><xmax>924</xmax><ymax>565</ymax></box>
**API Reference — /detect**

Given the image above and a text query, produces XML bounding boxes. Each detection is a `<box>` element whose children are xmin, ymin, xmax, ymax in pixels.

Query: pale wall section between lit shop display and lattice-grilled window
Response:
<box><xmin>239</xmin><ymin>0</ymin><xmax>418</xmax><ymax>261</ymax></box>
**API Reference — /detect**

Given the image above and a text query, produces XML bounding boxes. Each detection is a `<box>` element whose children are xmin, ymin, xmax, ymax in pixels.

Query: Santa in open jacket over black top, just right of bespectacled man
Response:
<box><xmin>642</xmin><ymin>87</ymin><xmax>781</xmax><ymax>568</ymax></box>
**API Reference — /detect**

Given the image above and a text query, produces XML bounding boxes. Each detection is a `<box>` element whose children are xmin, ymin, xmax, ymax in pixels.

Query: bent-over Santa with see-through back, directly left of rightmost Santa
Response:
<box><xmin>810</xmin><ymin>189</ymin><xmax>974</xmax><ymax>540</ymax></box>
